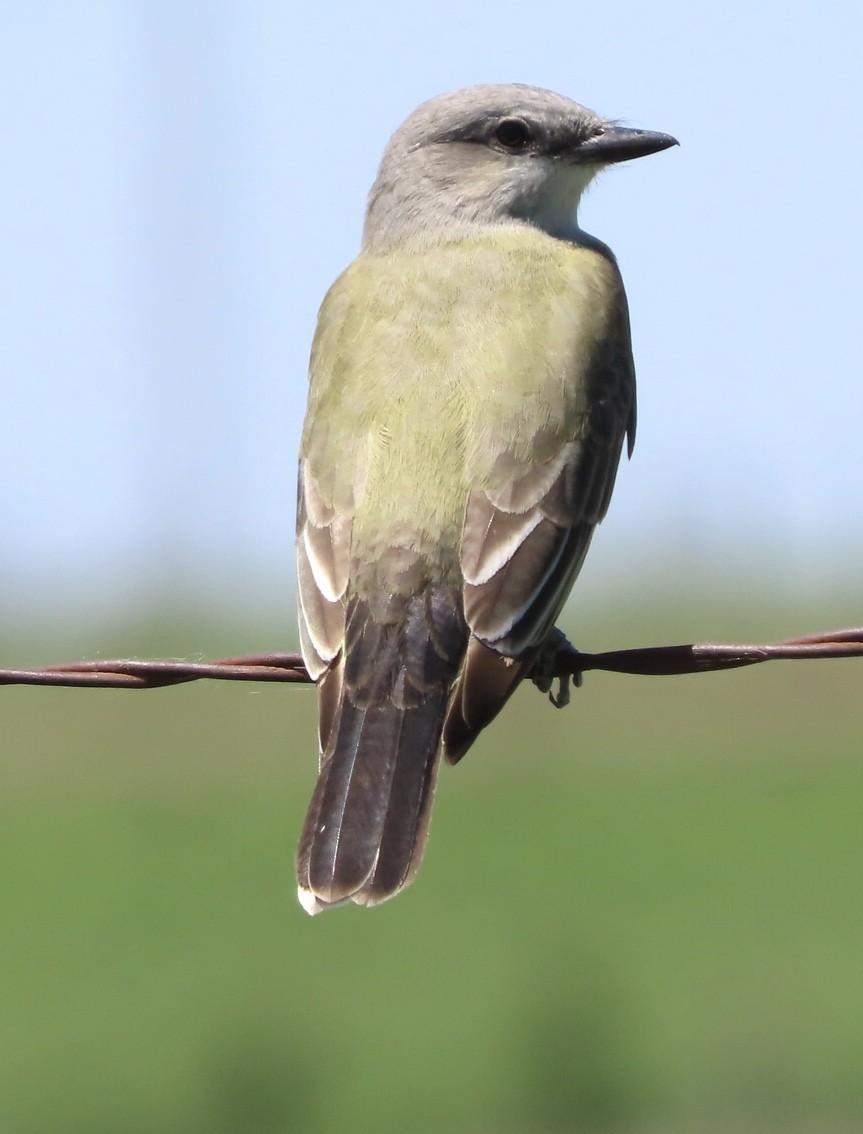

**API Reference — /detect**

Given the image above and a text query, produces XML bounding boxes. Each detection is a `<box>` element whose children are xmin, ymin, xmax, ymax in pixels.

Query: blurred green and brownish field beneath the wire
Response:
<box><xmin>0</xmin><ymin>604</ymin><xmax>863</xmax><ymax>1134</ymax></box>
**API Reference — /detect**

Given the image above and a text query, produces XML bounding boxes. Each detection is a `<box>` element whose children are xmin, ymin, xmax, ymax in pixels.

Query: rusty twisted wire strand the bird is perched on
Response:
<box><xmin>0</xmin><ymin>627</ymin><xmax>863</xmax><ymax>689</ymax></box>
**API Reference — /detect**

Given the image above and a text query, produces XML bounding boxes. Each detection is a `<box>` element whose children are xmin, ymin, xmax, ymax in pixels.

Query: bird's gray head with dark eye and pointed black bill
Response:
<box><xmin>363</xmin><ymin>83</ymin><xmax>677</xmax><ymax>252</ymax></box>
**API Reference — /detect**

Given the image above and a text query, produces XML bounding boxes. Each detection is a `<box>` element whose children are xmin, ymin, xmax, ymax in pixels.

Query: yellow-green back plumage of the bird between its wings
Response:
<box><xmin>302</xmin><ymin>229</ymin><xmax>631</xmax><ymax>594</ymax></box>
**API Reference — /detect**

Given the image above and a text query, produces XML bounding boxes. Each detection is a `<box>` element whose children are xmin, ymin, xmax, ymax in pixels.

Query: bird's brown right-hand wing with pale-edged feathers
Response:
<box><xmin>443</xmin><ymin>276</ymin><xmax>635</xmax><ymax>762</ymax></box>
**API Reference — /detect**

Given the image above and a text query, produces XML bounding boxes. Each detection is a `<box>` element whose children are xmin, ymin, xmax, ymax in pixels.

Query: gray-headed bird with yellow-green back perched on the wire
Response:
<box><xmin>297</xmin><ymin>84</ymin><xmax>676</xmax><ymax>914</ymax></box>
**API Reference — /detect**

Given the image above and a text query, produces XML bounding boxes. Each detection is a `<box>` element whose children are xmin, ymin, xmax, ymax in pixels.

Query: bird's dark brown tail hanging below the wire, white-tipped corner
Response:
<box><xmin>297</xmin><ymin>587</ymin><xmax>467</xmax><ymax>913</ymax></box>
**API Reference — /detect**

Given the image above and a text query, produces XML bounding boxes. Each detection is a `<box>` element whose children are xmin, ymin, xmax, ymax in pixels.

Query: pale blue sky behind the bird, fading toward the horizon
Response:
<box><xmin>0</xmin><ymin>0</ymin><xmax>863</xmax><ymax>623</ymax></box>
